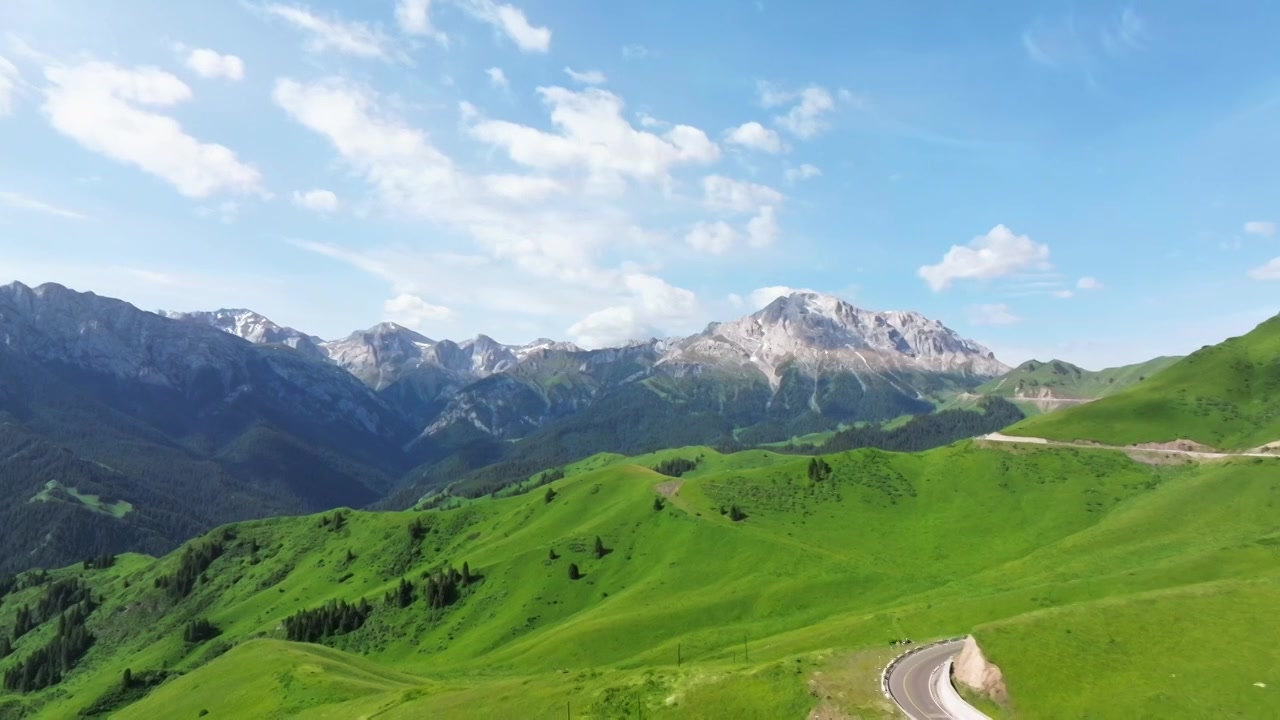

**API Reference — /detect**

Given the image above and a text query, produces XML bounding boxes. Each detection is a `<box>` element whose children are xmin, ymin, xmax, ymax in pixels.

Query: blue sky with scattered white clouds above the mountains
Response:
<box><xmin>0</xmin><ymin>0</ymin><xmax>1280</xmax><ymax>369</ymax></box>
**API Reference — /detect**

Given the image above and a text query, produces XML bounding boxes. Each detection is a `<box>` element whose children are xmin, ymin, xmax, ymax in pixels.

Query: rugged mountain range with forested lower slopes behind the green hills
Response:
<box><xmin>0</xmin><ymin>283</ymin><xmax>1009</xmax><ymax>571</ymax></box>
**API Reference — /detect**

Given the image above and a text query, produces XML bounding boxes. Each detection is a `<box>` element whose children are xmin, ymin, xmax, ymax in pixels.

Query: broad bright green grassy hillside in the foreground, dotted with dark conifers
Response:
<box><xmin>0</xmin><ymin>442</ymin><xmax>1280</xmax><ymax>719</ymax></box>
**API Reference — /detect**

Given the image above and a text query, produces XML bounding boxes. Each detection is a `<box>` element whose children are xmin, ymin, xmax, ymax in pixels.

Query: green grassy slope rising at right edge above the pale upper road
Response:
<box><xmin>1005</xmin><ymin>316</ymin><xmax>1280</xmax><ymax>450</ymax></box>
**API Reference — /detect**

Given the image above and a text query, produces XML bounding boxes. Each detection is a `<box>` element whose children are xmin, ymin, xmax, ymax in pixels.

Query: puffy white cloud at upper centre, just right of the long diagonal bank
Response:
<box><xmin>468</xmin><ymin>87</ymin><xmax>719</xmax><ymax>190</ymax></box>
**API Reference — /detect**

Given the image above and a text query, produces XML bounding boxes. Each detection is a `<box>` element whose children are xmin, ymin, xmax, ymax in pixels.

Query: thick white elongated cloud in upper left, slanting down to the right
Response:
<box><xmin>44</xmin><ymin>61</ymin><xmax>264</xmax><ymax>197</ymax></box>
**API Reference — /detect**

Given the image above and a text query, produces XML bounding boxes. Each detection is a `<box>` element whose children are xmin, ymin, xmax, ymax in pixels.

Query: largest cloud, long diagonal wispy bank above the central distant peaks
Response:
<box><xmin>273</xmin><ymin>78</ymin><xmax>721</xmax><ymax>345</ymax></box>
